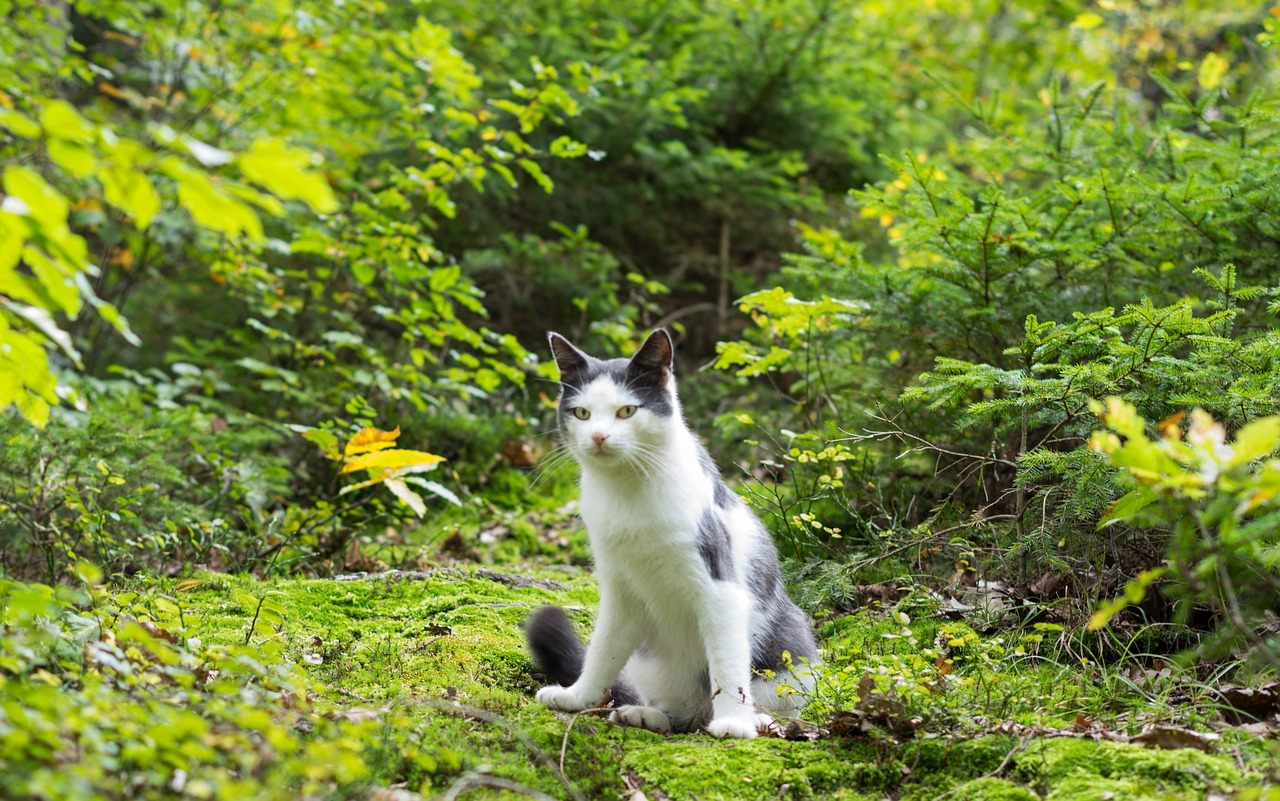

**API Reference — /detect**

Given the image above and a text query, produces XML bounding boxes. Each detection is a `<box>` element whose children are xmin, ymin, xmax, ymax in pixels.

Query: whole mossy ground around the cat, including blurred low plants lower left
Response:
<box><xmin>0</xmin><ymin>566</ymin><xmax>1276</xmax><ymax>800</ymax></box>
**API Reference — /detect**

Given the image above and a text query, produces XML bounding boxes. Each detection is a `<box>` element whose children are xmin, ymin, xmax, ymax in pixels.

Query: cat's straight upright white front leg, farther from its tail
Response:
<box><xmin>699</xmin><ymin>582</ymin><xmax>760</xmax><ymax>740</ymax></box>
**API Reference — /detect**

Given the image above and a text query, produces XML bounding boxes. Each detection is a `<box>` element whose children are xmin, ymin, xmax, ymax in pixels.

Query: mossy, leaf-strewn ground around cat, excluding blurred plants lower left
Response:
<box><xmin>154</xmin><ymin>566</ymin><xmax>1280</xmax><ymax>801</ymax></box>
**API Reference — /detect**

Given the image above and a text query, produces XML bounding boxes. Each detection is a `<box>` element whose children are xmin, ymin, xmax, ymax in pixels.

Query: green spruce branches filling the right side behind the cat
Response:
<box><xmin>717</xmin><ymin>3</ymin><xmax>1280</xmax><ymax>586</ymax></box>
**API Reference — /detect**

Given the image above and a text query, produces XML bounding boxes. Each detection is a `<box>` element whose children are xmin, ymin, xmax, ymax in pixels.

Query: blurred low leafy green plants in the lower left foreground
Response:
<box><xmin>0</xmin><ymin>573</ymin><xmax>350</xmax><ymax>798</ymax></box>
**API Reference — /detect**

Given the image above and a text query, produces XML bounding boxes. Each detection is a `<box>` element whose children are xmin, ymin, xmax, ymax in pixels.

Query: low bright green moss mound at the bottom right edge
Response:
<box><xmin>1015</xmin><ymin>738</ymin><xmax>1242</xmax><ymax>801</ymax></box>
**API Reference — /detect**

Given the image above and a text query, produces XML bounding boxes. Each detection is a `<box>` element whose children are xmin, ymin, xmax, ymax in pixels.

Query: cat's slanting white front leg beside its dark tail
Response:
<box><xmin>538</xmin><ymin>587</ymin><xmax>643</xmax><ymax>711</ymax></box>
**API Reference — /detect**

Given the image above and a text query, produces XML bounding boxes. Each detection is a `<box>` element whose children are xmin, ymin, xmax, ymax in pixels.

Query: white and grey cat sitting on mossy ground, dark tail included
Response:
<box><xmin>525</xmin><ymin>329</ymin><xmax>818</xmax><ymax>738</ymax></box>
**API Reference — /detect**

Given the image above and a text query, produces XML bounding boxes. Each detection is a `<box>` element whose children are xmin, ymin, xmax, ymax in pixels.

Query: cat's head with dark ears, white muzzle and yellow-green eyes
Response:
<box><xmin>548</xmin><ymin>329</ymin><xmax>680</xmax><ymax>472</ymax></box>
